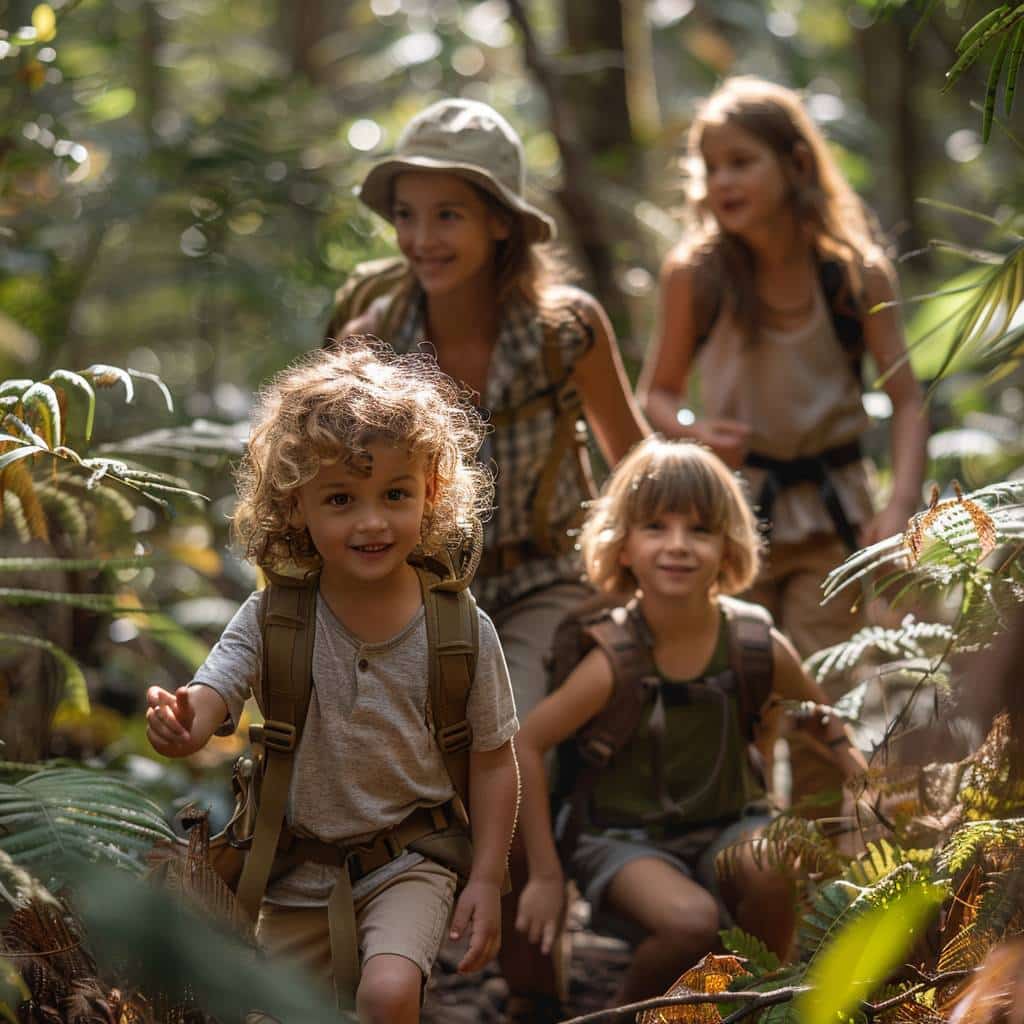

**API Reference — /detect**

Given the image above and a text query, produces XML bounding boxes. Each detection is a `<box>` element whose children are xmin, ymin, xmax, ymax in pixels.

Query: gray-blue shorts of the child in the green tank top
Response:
<box><xmin>568</xmin><ymin>809</ymin><xmax>772</xmax><ymax>939</ymax></box>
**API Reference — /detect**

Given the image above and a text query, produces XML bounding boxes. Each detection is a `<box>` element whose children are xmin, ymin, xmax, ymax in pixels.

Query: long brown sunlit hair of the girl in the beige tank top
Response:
<box><xmin>684</xmin><ymin>75</ymin><xmax>884</xmax><ymax>341</ymax></box>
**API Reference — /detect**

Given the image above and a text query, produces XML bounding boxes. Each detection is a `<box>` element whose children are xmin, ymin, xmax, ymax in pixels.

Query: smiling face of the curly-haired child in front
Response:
<box><xmin>292</xmin><ymin>441</ymin><xmax>434</xmax><ymax>586</ymax></box>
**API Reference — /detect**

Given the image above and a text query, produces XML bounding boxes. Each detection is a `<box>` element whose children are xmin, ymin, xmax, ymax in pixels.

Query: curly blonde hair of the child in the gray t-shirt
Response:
<box><xmin>233</xmin><ymin>335</ymin><xmax>494</xmax><ymax>568</ymax></box>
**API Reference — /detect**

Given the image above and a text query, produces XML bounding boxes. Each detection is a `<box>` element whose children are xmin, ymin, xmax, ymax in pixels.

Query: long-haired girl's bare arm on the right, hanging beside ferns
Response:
<box><xmin>861</xmin><ymin>260</ymin><xmax>928</xmax><ymax>545</ymax></box>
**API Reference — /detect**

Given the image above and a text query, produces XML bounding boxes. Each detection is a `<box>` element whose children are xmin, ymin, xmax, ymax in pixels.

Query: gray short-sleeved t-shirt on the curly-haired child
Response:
<box><xmin>193</xmin><ymin>592</ymin><xmax>518</xmax><ymax>906</ymax></box>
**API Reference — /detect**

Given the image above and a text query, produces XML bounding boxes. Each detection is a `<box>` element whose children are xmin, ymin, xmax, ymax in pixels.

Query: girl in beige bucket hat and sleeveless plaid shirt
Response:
<box><xmin>327</xmin><ymin>99</ymin><xmax>649</xmax><ymax>1021</ymax></box>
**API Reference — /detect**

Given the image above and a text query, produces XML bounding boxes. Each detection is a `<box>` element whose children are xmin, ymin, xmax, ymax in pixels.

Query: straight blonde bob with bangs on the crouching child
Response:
<box><xmin>580</xmin><ymin>437</ymin><xmax>761</xmax><ymax>594</ymax></box>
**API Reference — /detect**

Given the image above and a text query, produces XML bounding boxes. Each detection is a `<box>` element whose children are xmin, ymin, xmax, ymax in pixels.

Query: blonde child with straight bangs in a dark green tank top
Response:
<box><xmin>516</xmin><ymin>438</ymin><xmax>866</xmax><ymax>1004</ymax></box>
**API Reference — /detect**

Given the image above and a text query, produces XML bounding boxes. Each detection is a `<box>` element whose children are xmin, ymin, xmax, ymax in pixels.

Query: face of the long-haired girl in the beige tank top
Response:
<box><xmin>700</xmin><ymin>121</ymin><xmax>793</xmax><ymax>237</ymax></box>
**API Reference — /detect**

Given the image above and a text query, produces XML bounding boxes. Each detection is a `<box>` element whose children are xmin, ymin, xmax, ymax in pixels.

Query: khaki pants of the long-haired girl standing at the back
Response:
<box><xmin>743</xmin><ymin>534</ymin><xmax>867</xmax><ymax>817</ymax></box>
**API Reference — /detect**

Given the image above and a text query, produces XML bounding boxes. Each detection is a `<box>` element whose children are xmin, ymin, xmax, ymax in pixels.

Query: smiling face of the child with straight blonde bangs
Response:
<box><xmin>618</xmin><ymin>511</ymin><xmax>725</xmax><ymax>601</ymax></box>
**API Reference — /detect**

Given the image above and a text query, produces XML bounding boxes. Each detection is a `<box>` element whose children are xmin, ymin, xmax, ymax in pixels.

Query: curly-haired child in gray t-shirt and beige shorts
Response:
<box><xmin>146</xmin><ymin>337</ymin><xmax>518</xmax><ymax>1024</ymax></box>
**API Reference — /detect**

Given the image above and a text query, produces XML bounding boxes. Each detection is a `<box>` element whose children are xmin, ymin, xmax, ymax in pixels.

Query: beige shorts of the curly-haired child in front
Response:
<box><xmin>256</xmin><ymin>860</ymin><xmax>456</xmax><ymax>990</ymax></box>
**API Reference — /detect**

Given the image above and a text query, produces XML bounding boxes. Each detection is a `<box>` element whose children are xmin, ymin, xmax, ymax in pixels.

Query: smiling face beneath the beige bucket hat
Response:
<box><xmin>392</xmin><ymin>171</ymin><xmax>509</xmax><ymax>296</ymax></box>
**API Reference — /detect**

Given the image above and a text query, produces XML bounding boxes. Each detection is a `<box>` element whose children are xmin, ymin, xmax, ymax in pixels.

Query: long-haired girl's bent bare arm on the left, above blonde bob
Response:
<box><xmin>637</xmin><ymin>253</ymin><xmax>750</xmax><ymax>469</ymax></box>
